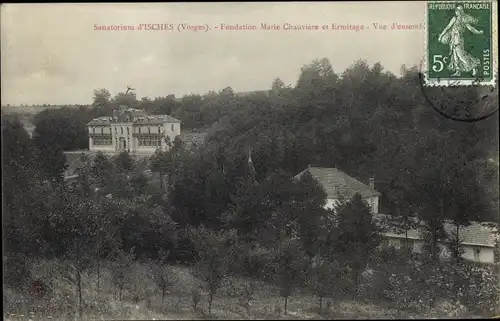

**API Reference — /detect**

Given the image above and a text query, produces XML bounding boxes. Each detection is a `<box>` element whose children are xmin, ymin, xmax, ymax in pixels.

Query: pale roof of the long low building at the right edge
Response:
<box><xmin>376</xmin><ymin>214</ymin><xmax>497</xmax><ymax>247</ymax></box>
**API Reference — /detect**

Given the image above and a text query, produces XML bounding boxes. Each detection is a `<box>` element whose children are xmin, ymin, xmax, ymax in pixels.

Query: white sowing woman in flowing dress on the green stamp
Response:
<box><xmin>438</xmin><ymin>6</ymin><xmax>483</xmax><ymax>77</ymax></box>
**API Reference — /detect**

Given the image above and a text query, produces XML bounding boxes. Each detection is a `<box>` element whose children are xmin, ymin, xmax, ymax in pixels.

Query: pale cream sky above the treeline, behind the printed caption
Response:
<box><xmin>0</xmin><ymin>1</ymin><xmax>425</xmax><ymax>105</ymax></box>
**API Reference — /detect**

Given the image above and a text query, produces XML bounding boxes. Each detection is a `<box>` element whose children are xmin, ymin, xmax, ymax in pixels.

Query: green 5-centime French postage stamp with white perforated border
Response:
<box><xmin>425</xmin><ymin>0</ymin><xmax>498</xmax><ymax>86</ymax></box>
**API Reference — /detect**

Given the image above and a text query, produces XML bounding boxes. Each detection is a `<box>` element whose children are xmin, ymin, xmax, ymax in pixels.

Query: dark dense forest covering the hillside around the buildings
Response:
<box><xmin>2</xmin><ymin>58</ymin><xmax>499</xmax><ymax>318</ymax></box>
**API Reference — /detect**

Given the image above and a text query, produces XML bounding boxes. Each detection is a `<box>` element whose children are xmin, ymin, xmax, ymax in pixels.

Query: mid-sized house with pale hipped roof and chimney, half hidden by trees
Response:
<box><xmin>295</xmin><ymin>166</ymin><xmax>380</xmax><ymax>214</ymax></box>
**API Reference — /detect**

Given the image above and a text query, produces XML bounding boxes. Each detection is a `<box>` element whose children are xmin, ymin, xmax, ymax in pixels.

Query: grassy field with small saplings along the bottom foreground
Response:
<box><xmin>4</xmin><ymin>261</ymin><xmax>476</xmax><ymax>321</ymax></box>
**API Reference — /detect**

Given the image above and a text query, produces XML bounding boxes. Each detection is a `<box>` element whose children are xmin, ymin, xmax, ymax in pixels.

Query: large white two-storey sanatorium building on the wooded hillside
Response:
<box><xmin>87</xmin><ymin>108</ymin><xmax>181</xmax><ymax>154</ymax></box>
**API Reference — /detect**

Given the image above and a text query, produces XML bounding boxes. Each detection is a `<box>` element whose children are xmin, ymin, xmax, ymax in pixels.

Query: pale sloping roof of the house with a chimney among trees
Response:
<box><xmin>295</xmin><ymin>167</ymin><xmax>380</xmax><ymax>199</ymax></box>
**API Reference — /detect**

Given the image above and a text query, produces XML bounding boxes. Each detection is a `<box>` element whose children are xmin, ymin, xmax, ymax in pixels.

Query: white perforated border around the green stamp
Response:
<box><xmin>422</xmin><ymin>0</ymin><xmax>498</xmax><ymax>87</ymax></box>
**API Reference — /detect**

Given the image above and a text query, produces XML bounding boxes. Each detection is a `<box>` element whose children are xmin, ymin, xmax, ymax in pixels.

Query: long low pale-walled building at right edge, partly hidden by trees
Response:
<box><xmin>375</xmin><ymin>214</ymin><xmax>496</xmax><ymax>263</ymax></box>
